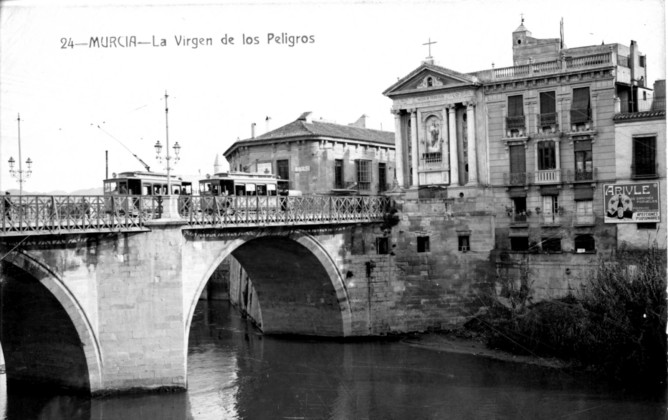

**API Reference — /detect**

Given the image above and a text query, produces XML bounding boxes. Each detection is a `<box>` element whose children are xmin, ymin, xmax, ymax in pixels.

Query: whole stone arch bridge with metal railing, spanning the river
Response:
<box><xmin>0</xmin><ymin>196</ymin><xmax>408</xmax><ymax>394</ymax></box>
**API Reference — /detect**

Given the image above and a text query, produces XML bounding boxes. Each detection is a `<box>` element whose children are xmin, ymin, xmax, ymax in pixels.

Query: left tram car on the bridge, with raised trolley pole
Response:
<box><xmin>103</xmin><ymin>171</ymin><xmax>192</xmax><ymax>216</ymax></box>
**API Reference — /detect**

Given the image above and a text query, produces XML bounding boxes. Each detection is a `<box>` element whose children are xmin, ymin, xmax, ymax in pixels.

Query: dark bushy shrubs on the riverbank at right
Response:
<box><xmin>479</xmin><ymin>249</ymin><xmax>667</xmax><ymax>383</ymax></box>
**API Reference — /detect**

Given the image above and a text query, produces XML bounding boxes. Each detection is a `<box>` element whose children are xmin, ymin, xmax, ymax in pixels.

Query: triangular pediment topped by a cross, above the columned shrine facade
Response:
<box><xmin>383</xmin><ymin>63</ymin><xmax>479</xmax><ymax>97</ymax></box>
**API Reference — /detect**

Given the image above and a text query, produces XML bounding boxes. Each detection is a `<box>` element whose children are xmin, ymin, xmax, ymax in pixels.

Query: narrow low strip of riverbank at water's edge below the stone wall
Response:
<box><xmin>401</xmin><ymin>330</ymin><xmax>572</xmax><ymax>369</ymax></box>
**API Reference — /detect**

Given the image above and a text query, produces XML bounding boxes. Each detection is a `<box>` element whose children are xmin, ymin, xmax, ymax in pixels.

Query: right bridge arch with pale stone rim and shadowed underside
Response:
<box><xmin>184</xmin><ymin>230</ymin><xmax>352</xmax><ymax>345</ymax></box>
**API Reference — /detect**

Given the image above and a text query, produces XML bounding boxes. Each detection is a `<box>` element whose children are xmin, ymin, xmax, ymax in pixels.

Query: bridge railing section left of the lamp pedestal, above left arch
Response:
<box><xmin>0</xmin><ymin>195</ymin><xmax>162</xmax><ymax>234</ymax></box>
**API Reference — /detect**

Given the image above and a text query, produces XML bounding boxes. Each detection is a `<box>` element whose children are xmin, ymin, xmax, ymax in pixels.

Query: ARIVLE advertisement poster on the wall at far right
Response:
<box><xmin>603</xmin><ymin>182</ymin><xmax>661</xmax><ymax>223</ymax></box>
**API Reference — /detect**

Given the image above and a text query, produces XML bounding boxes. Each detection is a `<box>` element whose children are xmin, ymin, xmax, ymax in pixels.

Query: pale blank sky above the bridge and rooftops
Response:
<box><xmin>0</xmin><ymin>0</ymin><xmax>666</xmax><ymax>193</ymax></box>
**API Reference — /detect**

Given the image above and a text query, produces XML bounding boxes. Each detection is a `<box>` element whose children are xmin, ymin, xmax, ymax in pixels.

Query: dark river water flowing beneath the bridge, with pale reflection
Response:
<box><xmin>0</xmin><ymin>301</ymin><xmax>666</xmax><ymax>420</ymax></box>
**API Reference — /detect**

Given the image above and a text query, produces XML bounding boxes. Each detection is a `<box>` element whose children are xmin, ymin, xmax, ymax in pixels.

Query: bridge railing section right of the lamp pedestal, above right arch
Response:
<box><xmin>179</xmin><ymin>195</ymin><xmax>389</xmax><ymax>226</ymax></box>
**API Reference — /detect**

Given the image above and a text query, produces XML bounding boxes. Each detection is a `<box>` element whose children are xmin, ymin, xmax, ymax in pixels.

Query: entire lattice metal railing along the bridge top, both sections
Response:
<box><xmin>0</xmin><ymin>195</ymin><xmax>388</xmax><ymax>237</ymax></box>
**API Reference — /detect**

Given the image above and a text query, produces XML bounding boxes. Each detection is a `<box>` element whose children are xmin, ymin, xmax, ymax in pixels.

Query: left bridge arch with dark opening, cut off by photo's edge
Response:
<box><xmin>2</xmin><ymin>251</ymin><xmax>103</xmax><ymax>394</ymax></box>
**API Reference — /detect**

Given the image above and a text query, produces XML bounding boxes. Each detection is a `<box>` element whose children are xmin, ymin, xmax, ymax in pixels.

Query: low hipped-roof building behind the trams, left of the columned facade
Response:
<box><xmin>223</xmin><ymin>112</ymin><xmax>396</xmax><ymax>194</ymax></box>
